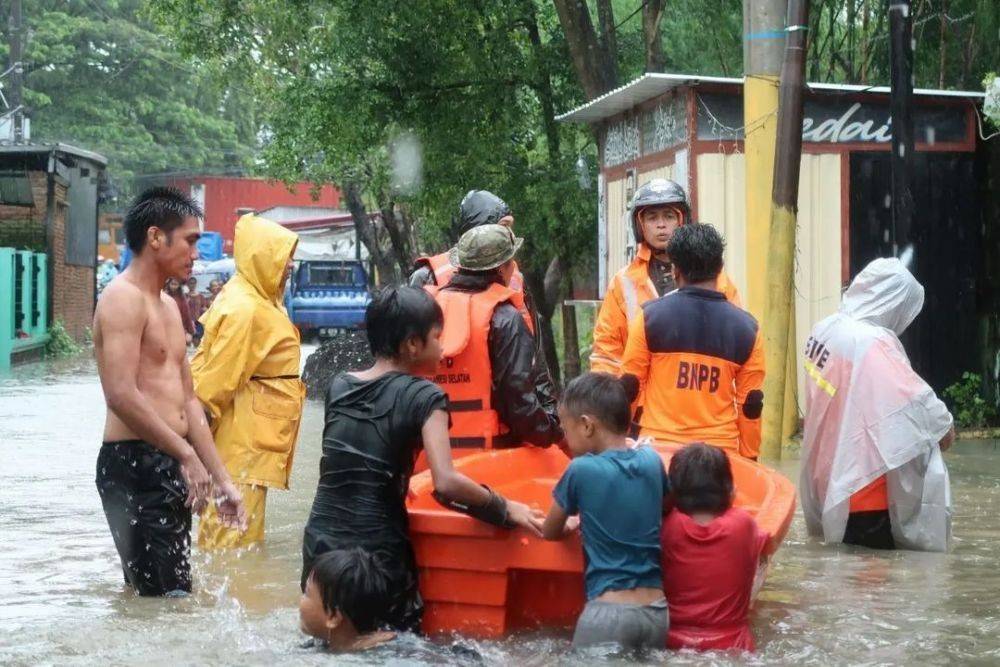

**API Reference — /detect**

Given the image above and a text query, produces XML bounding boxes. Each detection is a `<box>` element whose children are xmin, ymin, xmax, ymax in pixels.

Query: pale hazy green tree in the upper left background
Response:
<box><xmin>2</xmin><ymin>0</ymin><xmax>259</xmax><ymax>197</ymax></box>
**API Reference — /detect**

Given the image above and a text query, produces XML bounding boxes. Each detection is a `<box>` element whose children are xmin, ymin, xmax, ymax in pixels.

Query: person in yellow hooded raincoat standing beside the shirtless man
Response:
<box><xmin>191</xmin><ymin>215</ymin><xmax>305</xmax><ymax>549</ymax></box>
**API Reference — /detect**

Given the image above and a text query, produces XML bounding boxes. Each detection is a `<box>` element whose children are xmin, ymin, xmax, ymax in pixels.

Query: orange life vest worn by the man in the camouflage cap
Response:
<box><xmin>428</xmin><ymin>283</ymin><xmax>532</xmax><ymax>456</ymax></box>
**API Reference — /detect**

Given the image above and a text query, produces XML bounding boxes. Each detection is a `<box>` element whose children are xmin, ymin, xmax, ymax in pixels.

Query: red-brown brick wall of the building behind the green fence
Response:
<box><xmin>0</xmin><ymin>171</ymin><xmax>95</xmax><ymax>340</ymax></box>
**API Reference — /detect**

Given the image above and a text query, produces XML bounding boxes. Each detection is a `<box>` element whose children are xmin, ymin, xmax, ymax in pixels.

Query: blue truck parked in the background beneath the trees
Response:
<box><xmin>286</xmin><ymin>260</ymin><xmax>371</xmax><ymax>338</ymax></box>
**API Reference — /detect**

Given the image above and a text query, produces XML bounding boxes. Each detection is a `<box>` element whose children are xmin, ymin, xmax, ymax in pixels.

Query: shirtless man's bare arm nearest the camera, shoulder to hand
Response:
<box><xmin>95</xmin><ymin>285</ymin><xmax>208</xmax><ymax>506</ymax></box>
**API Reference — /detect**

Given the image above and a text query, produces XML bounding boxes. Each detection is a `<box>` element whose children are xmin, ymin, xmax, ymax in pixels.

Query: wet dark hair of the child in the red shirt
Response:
<box><xmin>667</xmin><ymin>442</ymin><xmax>733</xmax><ymax>514</ymax></box>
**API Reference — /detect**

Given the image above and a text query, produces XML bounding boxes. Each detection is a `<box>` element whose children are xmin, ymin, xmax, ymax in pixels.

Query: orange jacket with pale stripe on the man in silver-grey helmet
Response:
<box><xmin>590</xmin><ymin>243</ymin><xmax>742</xmax><ymax>375</ymax></box>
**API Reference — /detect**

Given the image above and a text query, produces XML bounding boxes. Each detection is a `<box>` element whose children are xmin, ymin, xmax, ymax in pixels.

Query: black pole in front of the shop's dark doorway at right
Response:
<box><xmin>889</xmin><ymin>0</ymin><xmax>914</xmax><ymax>257</ymax></box>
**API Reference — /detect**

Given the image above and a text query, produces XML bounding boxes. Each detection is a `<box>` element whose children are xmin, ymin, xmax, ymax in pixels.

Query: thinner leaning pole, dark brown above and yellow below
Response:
<box><xmin>761</xmin><ymin>0</ymin><xmax>809</xmax><ymax>456</ymax></box>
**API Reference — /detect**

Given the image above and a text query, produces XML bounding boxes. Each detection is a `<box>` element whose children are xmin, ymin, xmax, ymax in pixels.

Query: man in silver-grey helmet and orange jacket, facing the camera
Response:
<box><xmin>590</xmin><ymin>178</ymin><xmax>741</xmax><ymax>375</ymax></box>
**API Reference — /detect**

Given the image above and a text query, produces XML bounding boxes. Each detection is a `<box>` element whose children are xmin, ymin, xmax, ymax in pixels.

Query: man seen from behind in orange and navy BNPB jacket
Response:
<box><xmin>622</xmin><ymin>225</ymin><xmax>764</xmax><ymax>459</ymax></box>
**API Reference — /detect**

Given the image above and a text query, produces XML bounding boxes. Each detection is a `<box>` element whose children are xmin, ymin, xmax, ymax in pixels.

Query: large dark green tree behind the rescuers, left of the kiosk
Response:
<box><xmin>153</xmin><ymin>0</ymin><xmax>596</xmax><ymax>386</ymax></box>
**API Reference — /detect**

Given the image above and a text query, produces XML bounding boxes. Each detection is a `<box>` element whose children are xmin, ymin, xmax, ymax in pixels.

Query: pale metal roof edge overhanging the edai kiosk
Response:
<box><xmin>556</xmin><ymin>72</ymin><xmax>985</xmax><ymax>123</ymax></box>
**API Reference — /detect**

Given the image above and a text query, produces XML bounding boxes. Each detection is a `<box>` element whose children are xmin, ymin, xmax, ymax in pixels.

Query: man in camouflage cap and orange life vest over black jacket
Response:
<box><xmin>428</xmin><ymin>224</ymin><xmax>563</xmax><ymax>456</ymax></box>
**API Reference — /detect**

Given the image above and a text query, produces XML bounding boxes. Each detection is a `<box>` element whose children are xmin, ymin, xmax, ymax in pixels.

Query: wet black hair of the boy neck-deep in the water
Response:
<box><xmin>309</xmin><ymin>547</ymin><xmax>390</xmax><ymax>634</ymax></box>
